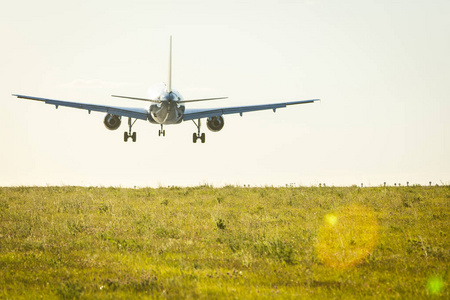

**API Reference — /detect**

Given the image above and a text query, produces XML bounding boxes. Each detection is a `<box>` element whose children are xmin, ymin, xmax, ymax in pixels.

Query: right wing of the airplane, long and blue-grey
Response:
<box><xmin>183</xmin><ymin>99</ymin><xmax>319</xmax><ymax>121</ymax></box>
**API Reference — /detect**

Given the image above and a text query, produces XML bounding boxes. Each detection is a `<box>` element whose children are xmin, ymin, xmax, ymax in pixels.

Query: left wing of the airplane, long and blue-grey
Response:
<box><xmin>13</xmin><ymin>94</ymin><xmax>148</xmax><ymax>120</ymax></box>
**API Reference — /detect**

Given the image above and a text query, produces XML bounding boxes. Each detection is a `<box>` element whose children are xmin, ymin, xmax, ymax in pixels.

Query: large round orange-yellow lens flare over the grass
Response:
<box><xmin>316</xmin><ymin>204</ymin><xmax>378</xmax><ymax>269</ymax></box>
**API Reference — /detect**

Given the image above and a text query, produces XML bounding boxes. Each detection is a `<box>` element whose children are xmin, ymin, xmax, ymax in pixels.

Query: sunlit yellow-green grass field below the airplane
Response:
<box><xmin>0</xmin><ymin>186</ymin><xmax>450</xmax><ymax>299</ymax></box>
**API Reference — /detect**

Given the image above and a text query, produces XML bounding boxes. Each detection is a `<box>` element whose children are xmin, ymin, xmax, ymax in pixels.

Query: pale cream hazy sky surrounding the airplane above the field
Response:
<box><xmin>0</xmin><ymin>0</ymin><xmax>450</xmax><ymax>187</ymax></box>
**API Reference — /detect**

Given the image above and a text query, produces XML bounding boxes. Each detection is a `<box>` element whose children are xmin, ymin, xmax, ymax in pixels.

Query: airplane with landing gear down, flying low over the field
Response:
<box><xmin>13</xmin><ymin>36</ymin><xmax>320</xmax><ymax>143</ymax></box>
